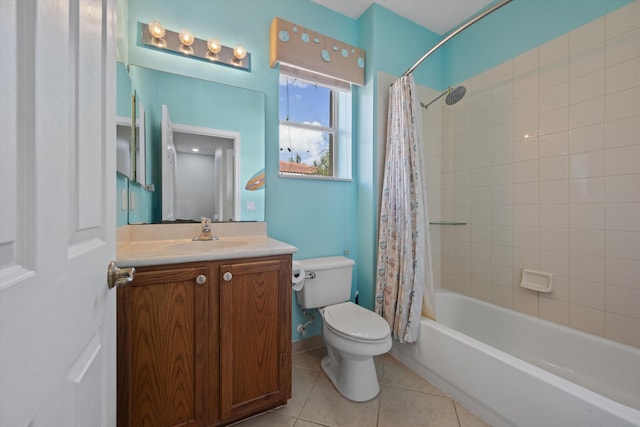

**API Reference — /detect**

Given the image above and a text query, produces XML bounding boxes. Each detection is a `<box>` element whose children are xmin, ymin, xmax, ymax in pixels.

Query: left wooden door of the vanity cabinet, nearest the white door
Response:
<box><xmin>118</xmin><ymin>266</ymin><xmax>209</xmax><ymax>427</ymax></box>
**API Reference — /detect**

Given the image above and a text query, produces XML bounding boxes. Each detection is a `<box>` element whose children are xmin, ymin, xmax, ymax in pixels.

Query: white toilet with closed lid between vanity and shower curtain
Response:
<box><xmin>293</xmin><ymin>256</ymin><xmax>391</xmax><ymax>402</ymax></box>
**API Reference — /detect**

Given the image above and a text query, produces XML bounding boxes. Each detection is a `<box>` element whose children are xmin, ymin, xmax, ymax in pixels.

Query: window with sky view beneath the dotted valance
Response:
<box><xmin>279</xmin><ymin>66</ymin><xmax>351</xmax><ymax>179</ymax></box>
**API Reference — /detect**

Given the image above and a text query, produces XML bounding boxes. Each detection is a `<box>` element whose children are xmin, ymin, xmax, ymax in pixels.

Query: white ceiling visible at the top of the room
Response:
<box><xmin>312</xmin><ymin>0</ymin><xmax>493</xmax><ymax>35</ymax></box>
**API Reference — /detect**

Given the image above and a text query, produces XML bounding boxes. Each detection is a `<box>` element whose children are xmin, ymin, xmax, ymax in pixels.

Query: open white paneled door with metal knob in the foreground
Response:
<box><xmin>0</xmin><ymin>0</ymin><xmax>116</xmax><ymax>427</ymax></box>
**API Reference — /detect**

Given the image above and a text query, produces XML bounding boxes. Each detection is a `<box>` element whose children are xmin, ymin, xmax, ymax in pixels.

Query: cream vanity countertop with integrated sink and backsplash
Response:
<box><xmin>116</xmin><ymin>223</ymin><xmax>298</xmax><ymax>267</ymax></box>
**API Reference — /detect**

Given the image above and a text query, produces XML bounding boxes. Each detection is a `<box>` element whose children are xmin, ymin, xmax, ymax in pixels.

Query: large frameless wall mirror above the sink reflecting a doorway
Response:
<box><xmin>118</xmin><ymin>65</ymin><xmax>265</xmax><ymax>223</ymax></box>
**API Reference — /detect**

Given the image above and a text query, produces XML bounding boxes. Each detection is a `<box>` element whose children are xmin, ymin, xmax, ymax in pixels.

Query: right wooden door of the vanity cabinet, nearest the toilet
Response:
<box><xmin>219</xmin><ymin>256</ymin><xmax>291</xmax><ymax>420</ymax></box>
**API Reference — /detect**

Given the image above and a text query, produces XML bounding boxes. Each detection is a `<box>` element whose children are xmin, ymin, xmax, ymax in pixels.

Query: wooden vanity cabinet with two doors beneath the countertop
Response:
<box><xmin>117</xmin><ymin>254</ymin><xmax>291</xmax><ymax>427</ymax></box>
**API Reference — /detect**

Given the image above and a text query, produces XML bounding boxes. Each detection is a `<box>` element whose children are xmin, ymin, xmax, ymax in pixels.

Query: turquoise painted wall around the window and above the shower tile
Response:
<box><xmin>128</xmin><ymin>0</ymin><xmax>630</xmax><ymax>340</ymax></box>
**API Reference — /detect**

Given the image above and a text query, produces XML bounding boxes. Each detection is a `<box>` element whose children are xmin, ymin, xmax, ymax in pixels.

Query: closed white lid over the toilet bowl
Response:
<box><xmin>324</xmin><ymin>302</ymin><xmax>391</xmax><ymax>341</ymax></box>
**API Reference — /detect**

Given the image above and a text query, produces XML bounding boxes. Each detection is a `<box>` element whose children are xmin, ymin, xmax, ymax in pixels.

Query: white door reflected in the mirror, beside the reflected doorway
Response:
<box><xmin>161</xmin><ymin>105</ymin><xmax>178</xmax><ymax>221</ymax></box>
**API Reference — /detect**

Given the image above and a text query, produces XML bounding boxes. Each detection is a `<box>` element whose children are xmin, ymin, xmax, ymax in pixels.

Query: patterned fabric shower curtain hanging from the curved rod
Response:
<box><xmin>375</xmin><ymin>74</ymin><xmax>434</xmax><ymax>343</ymax></box>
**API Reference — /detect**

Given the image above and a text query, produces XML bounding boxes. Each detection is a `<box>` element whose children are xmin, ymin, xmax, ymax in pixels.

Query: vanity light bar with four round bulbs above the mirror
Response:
<box><xmin>139</xmin><ymin>21</ymin><xmax>251</xmax><ymax>71</ymax></box>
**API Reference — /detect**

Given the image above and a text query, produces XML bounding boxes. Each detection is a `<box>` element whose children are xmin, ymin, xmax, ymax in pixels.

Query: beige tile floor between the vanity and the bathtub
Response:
<box><xmin>234</xmin><ymin>348</ymin><xmax>487</xmax><ymax>427</ymax></box>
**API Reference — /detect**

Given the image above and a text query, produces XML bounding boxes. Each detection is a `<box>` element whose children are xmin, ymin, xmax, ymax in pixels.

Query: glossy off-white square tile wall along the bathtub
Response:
<box><xmin>433</xmin><ymin>1</ymin><xmax>640</xmax><ymax>347</ymax></box>
